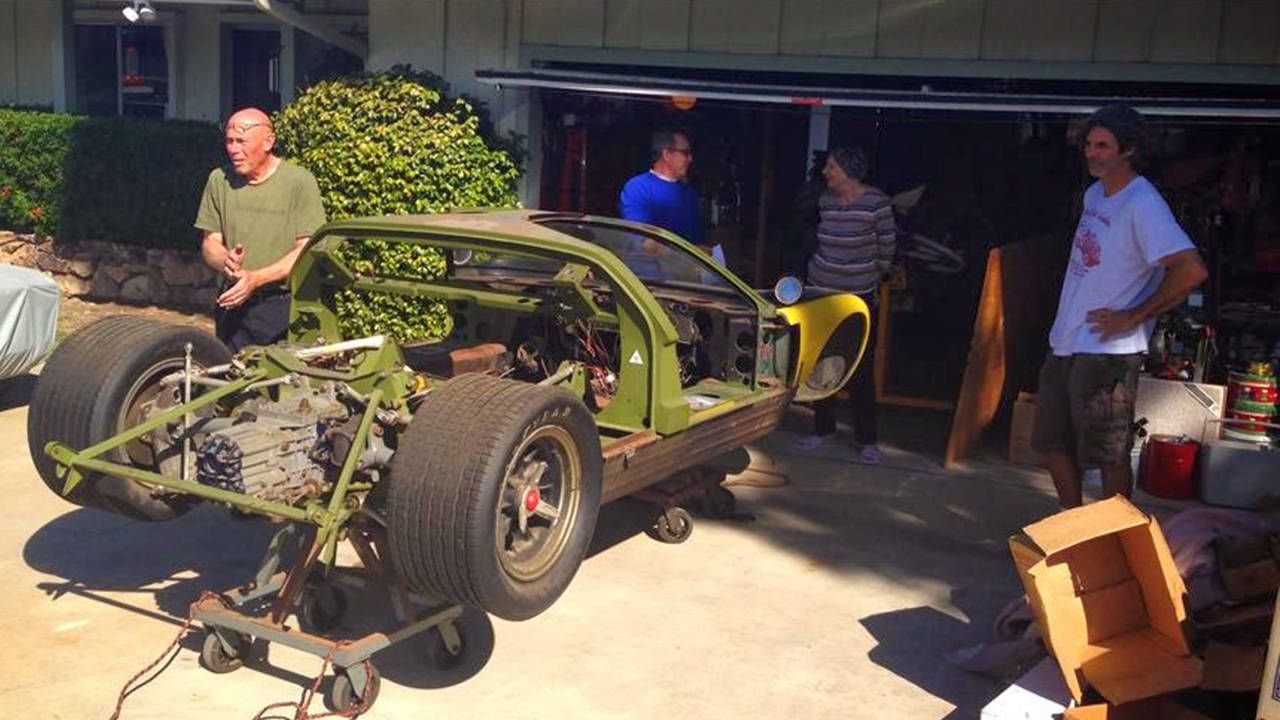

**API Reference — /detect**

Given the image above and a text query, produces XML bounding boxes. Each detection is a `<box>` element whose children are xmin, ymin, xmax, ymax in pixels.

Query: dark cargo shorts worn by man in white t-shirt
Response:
<box><xmin>1032</xmin><ymin>351</ymin><xmax>1143</xmax><ymax>468</ymax></box>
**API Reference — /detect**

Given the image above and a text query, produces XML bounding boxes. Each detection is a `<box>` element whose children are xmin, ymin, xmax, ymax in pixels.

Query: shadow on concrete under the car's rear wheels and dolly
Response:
<box><xmin>23</xmin><ymin>505</ymin><xmax>494</xmax><ymax>688</ymax></box>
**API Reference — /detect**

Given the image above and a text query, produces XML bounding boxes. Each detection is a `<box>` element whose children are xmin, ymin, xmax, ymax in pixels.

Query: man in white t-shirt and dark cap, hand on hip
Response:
<box><xmin>1032</xmin><ymin>105</ymin><xmax>1208</xmax><ymax>507</ymax></box>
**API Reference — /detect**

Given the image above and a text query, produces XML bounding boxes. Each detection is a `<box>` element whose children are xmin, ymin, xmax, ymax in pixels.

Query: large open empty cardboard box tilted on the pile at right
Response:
<box><xmin>1009</xmin><ymin>497</ymin><xmax>1201</xmax><ymax>705</ymax></box>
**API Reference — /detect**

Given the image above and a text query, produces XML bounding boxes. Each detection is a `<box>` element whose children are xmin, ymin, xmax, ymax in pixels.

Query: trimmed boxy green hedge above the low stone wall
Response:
<box><xmin>0</xmin><ymin>109</ymin><xmax>225</xmax><ymax>249</ymax></box>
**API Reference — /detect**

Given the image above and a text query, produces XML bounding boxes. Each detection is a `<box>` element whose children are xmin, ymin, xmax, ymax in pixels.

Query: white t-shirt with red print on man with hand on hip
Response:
<box><xmin>1050</xmin><ymin>176</ymin><xmax>1194</xmax><ymax>355</ymax></box>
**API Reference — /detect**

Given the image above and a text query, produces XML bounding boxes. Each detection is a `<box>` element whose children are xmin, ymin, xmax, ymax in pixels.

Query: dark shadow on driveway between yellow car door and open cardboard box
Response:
<box><xmin>735</xmin><ymin>410</ymin><xmax>1057</xmax><ymax>719</ymax></box>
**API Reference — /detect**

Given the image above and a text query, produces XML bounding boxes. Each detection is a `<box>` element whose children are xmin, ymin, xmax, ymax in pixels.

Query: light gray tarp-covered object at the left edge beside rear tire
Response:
<box><xmin>0</xmin><ymin>264</ymin><xmax>61</xmax><ymax>379</ymax></box>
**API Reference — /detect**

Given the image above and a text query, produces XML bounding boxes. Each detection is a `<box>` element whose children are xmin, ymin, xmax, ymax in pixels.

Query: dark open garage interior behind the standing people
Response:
<box><xmin>486</xmin><ymin>65</ymin><xmax>1280</xmax><ymax>452</ymax></box>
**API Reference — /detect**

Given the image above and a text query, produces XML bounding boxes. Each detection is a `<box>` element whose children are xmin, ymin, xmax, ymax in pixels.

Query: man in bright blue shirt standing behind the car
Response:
<box><xmin>618</xmin><ymin>131</ymin><xmax>724</xmax><ymax>265</ymax></box>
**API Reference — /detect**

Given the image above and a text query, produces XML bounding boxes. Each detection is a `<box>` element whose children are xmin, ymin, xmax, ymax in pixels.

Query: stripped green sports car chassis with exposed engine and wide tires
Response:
<box><xmin>28</xmin><ymin>210</ymin><xmax>868</xmax><ymax>707</ymax></box>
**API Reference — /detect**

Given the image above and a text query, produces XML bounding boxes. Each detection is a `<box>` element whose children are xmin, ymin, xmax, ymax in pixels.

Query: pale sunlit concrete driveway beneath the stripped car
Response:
<box><xmin>0</xmin><ymin>380</ymin><xmax>1056</xmax><ymax>720</ymax></box>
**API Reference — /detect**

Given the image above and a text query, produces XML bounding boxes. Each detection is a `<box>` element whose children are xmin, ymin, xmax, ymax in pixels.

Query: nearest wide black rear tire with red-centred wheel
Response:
<box><xmin>387</xmin><ymin>375</ymin><xmax>603</xmax><ymax>620</ymax></box>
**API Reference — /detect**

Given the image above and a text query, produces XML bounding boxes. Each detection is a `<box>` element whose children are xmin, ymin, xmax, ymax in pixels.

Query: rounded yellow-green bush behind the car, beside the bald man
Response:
<box><xmin>275</xmin><ymin>67</ymin><xmax>520</xmax><ymax>341</ymax></box>
